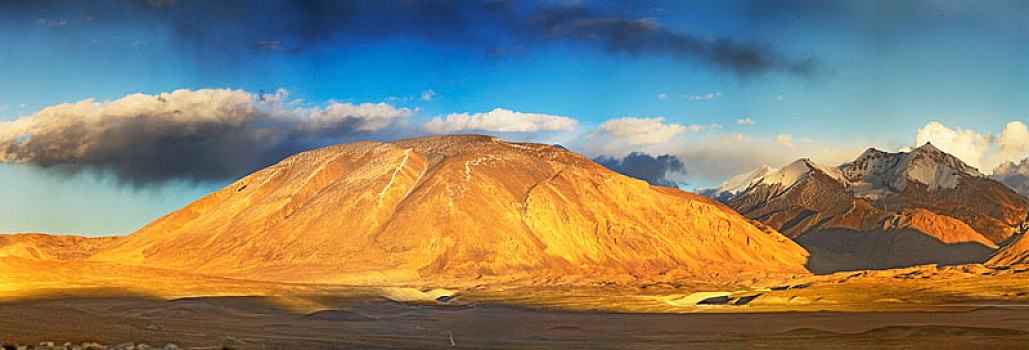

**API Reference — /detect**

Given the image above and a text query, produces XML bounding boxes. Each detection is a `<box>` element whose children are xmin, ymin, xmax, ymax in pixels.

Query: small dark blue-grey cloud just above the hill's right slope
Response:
<box><xmin>593</xmin><ymin>152</ymin><xmax>685</xmax><ymax>187</ymax></box>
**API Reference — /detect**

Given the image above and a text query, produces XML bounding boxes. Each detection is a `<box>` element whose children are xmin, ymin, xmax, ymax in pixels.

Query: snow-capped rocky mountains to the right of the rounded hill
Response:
<box><xmin>712</xmin><ymin>144</ymin><xmax>1029</xmax><ymax>273</ymax></box>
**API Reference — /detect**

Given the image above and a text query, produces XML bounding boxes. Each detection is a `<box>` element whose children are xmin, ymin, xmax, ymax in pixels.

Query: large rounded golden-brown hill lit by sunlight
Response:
<box><xmin>91</xmin><ymin>135</ymin><xmax>807</xmax><ymax>283</ymax></box>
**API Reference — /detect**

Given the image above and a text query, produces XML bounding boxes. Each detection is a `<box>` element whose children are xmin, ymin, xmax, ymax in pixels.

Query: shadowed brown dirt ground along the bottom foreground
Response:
<box><xmin>6</xmin><ymin>296</ymin><xmax>1029</xmax><ymax>349</ymax></box>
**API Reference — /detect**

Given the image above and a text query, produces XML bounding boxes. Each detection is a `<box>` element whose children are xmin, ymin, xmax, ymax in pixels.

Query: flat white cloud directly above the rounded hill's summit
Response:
<box><xmin>424</xmin><ymin>108</ymin><xmax>578</xmax><ymax>134</ymax></box>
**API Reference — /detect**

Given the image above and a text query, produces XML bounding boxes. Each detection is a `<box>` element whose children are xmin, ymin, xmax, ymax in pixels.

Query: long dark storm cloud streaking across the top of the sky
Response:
<box><xmin>6</xmin><ymin>0</ymin><xmax>818</xmax><ymax>76</ymax></box>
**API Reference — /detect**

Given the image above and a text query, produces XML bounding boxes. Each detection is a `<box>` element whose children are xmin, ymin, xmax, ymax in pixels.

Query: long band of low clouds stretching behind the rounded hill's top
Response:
<box><xmin>0</xmin><ymin>85</ymin><xmax>868</xmax><ymax>192</ymax></box>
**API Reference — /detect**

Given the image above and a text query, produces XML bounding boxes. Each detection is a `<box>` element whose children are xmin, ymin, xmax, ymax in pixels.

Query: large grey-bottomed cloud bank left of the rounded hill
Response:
<box><xmin>0</xmin><ymin>90</ymin><xmax>412</xmax><ymax>185</ymax></box>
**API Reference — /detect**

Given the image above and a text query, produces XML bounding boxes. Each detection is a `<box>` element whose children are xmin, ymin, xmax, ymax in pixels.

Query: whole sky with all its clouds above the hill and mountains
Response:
<box><xmin>0</xmin><ymin>0</ymin><xmax>1029</xmax><ymax>236</ymax></box>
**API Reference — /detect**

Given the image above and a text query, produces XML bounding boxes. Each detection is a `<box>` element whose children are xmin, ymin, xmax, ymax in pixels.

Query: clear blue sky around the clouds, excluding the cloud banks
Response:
<box><xmin>0</xmin><ymin>1</ymin><xmax>1029</xmax><ymax>235</ymax></box>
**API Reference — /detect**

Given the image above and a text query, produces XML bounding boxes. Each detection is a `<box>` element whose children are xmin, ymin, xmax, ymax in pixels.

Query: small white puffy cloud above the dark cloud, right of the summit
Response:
<box><xmin>597</xmin><ymin>116</ymin><xmax>687</xmax><ymax>145</ymax></box>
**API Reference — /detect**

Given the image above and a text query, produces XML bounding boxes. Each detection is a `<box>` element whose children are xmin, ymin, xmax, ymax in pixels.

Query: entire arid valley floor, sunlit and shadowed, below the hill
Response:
<box><xmin>0</xmin><ymin>259</ymin><xmax>1029</xmax><ymax>349</ymax></box>
